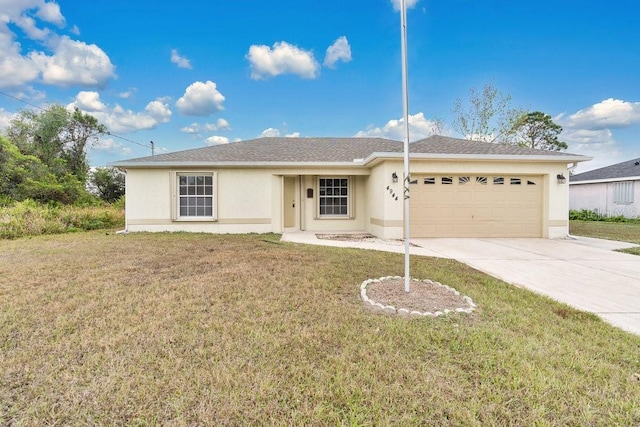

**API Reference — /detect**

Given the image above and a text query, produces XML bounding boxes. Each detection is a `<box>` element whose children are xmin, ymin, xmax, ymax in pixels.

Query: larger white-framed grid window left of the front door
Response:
<box><xmin>177</xmin><ymin>173</ymin><xmax>215</xmax><ymax>219</ymax></box>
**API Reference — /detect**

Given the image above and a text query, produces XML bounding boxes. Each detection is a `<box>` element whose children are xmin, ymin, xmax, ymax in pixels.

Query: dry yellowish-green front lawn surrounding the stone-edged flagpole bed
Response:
<box><xmin>0</xmin><ymin>232</ymin><xmax>640</xmax><ymax>426</ymax></box>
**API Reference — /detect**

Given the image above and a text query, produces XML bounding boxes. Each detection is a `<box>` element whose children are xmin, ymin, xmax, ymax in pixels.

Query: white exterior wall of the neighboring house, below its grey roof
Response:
<box><xmin>569</xmin><ymin>180</ymin><xmax>640</xmax><ymax>218</ymax></box>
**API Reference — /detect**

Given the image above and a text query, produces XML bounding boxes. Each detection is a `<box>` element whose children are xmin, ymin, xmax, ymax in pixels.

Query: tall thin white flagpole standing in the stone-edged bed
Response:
<box><xmin>400</xmin><ymin>0</ymin><xmax>411</xmax><ymax>292</ymax></box>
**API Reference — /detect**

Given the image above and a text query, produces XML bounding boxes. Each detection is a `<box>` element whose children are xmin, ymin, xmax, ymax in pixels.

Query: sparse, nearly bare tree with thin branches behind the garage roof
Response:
<box><xmin>452</xmin><ymin>84</ymin><xmax>526</xmax><ymax>142</ymax></box>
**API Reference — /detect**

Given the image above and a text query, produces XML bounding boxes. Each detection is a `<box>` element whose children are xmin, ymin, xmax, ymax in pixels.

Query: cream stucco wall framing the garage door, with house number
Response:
<box><xmin>370</xmin><ymin>160</ymin><xmax>569</xmax><ymax>239</ymax></box>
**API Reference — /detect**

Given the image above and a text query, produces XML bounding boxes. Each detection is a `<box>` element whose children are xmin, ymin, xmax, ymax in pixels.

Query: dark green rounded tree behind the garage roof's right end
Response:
<box><xmin>509</xmin><ymin>111</ymin><xmax>568</xmax><ymax>151</ymax></box>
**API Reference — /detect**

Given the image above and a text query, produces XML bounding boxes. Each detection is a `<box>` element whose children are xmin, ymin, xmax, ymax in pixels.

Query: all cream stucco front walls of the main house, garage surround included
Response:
<box><xmin>126</xmin><ymin>160</ymin><xmax>576</xmax><ymax>239</ymax></box>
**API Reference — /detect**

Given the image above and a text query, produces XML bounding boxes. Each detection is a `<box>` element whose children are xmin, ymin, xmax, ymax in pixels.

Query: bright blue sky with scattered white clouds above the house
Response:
<box><xmin>0</xmin><ymin>0</ymin><xmax>640</xmax><ymax>172</ymax></box>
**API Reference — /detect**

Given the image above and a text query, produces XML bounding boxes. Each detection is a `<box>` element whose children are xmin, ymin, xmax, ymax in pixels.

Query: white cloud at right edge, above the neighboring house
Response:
<box><xmin>557</xmin><ymin>98</ymin><xmax>640</xmax><ymax>129</ymax></box>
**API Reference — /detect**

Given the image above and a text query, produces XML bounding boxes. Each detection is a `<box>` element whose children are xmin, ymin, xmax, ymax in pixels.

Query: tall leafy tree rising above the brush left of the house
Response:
<box><xmin>7</xmin><ymin>104</ymin><xmax>107</xmax><ymax>183</ymax></box>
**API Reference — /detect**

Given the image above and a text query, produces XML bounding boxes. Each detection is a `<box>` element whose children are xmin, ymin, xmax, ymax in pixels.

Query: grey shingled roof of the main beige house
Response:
<box><xmin>111</xmin><ymin>136</ymin><xmax>589</xmax><ymax>167</ymax></box>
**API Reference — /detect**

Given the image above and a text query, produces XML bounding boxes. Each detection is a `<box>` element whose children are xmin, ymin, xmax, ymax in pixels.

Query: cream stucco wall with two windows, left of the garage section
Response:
<box><xmin>126</xmin><ymin>168</ymin><xmax>369</xmax><ymax>233</ymax></box>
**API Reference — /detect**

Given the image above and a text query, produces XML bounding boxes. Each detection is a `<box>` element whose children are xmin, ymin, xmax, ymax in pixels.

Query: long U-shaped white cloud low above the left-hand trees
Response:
<box><xmin>68</xmin><ymin>91</ymin><xmax>172</xmax><ymax>133</ymax></box>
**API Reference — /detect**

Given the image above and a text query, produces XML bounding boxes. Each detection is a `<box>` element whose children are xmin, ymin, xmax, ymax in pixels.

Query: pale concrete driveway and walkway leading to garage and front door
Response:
<box><xmin>282</xmin><ymin>232</ymin><xmax>640</xmax><ymax>335</ymax></box>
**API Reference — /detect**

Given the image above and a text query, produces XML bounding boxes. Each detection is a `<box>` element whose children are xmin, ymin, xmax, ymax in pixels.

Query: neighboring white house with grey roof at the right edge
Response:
<box><xmin>569</xmin><ymin>159</ymin><xmax>640</xmax><ymax>218</ymax></box>
